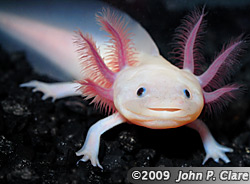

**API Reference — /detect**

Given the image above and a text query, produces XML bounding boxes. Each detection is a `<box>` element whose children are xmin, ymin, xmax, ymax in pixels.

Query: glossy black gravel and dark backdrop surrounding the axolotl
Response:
<box><xmin>0</xmin><ymin>1</ymin><xmax>250</xmax><ymax>184</ymax></box>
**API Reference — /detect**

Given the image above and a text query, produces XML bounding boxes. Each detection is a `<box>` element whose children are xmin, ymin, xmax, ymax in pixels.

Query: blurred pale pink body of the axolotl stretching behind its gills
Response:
<box><xmin>0</xmin><ymin>12</ymin><xmax>80</xmax><ymax>78</ymax></box>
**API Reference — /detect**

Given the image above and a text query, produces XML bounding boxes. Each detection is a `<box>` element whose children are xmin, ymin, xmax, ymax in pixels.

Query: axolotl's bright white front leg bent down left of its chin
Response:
<box><xmin>76</xmin><ymin>112</ymin><xmax>126</xmax><ymax>168</ymax></box>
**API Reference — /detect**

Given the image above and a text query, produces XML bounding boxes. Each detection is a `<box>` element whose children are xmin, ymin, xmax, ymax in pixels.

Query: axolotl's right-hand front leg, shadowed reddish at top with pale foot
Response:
<box><xmin>186</xmin><ymin>119</ymin><xmax>233</xmax><ymax>165</ymax></box>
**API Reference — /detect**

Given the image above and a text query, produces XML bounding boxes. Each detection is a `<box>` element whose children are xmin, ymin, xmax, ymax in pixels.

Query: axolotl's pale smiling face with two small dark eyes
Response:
<box><xmin>113</xmin><ymin>52</ymin><xmax>204</xmax><ymax>129</ymax></box>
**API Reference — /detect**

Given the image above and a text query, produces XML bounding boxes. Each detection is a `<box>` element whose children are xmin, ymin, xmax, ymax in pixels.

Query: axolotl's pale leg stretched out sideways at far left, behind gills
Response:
<box><xmin>20</xmin><ymin>80</ymin><xmax>82</xmax><ymax>102</ymax></box>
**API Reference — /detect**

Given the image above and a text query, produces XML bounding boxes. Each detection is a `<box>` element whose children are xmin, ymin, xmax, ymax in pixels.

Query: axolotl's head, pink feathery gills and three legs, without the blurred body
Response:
<box><xmin>17</xmin><ymin>9</ymin><xmax>245</xmax><ymax>168</ymax></box>
